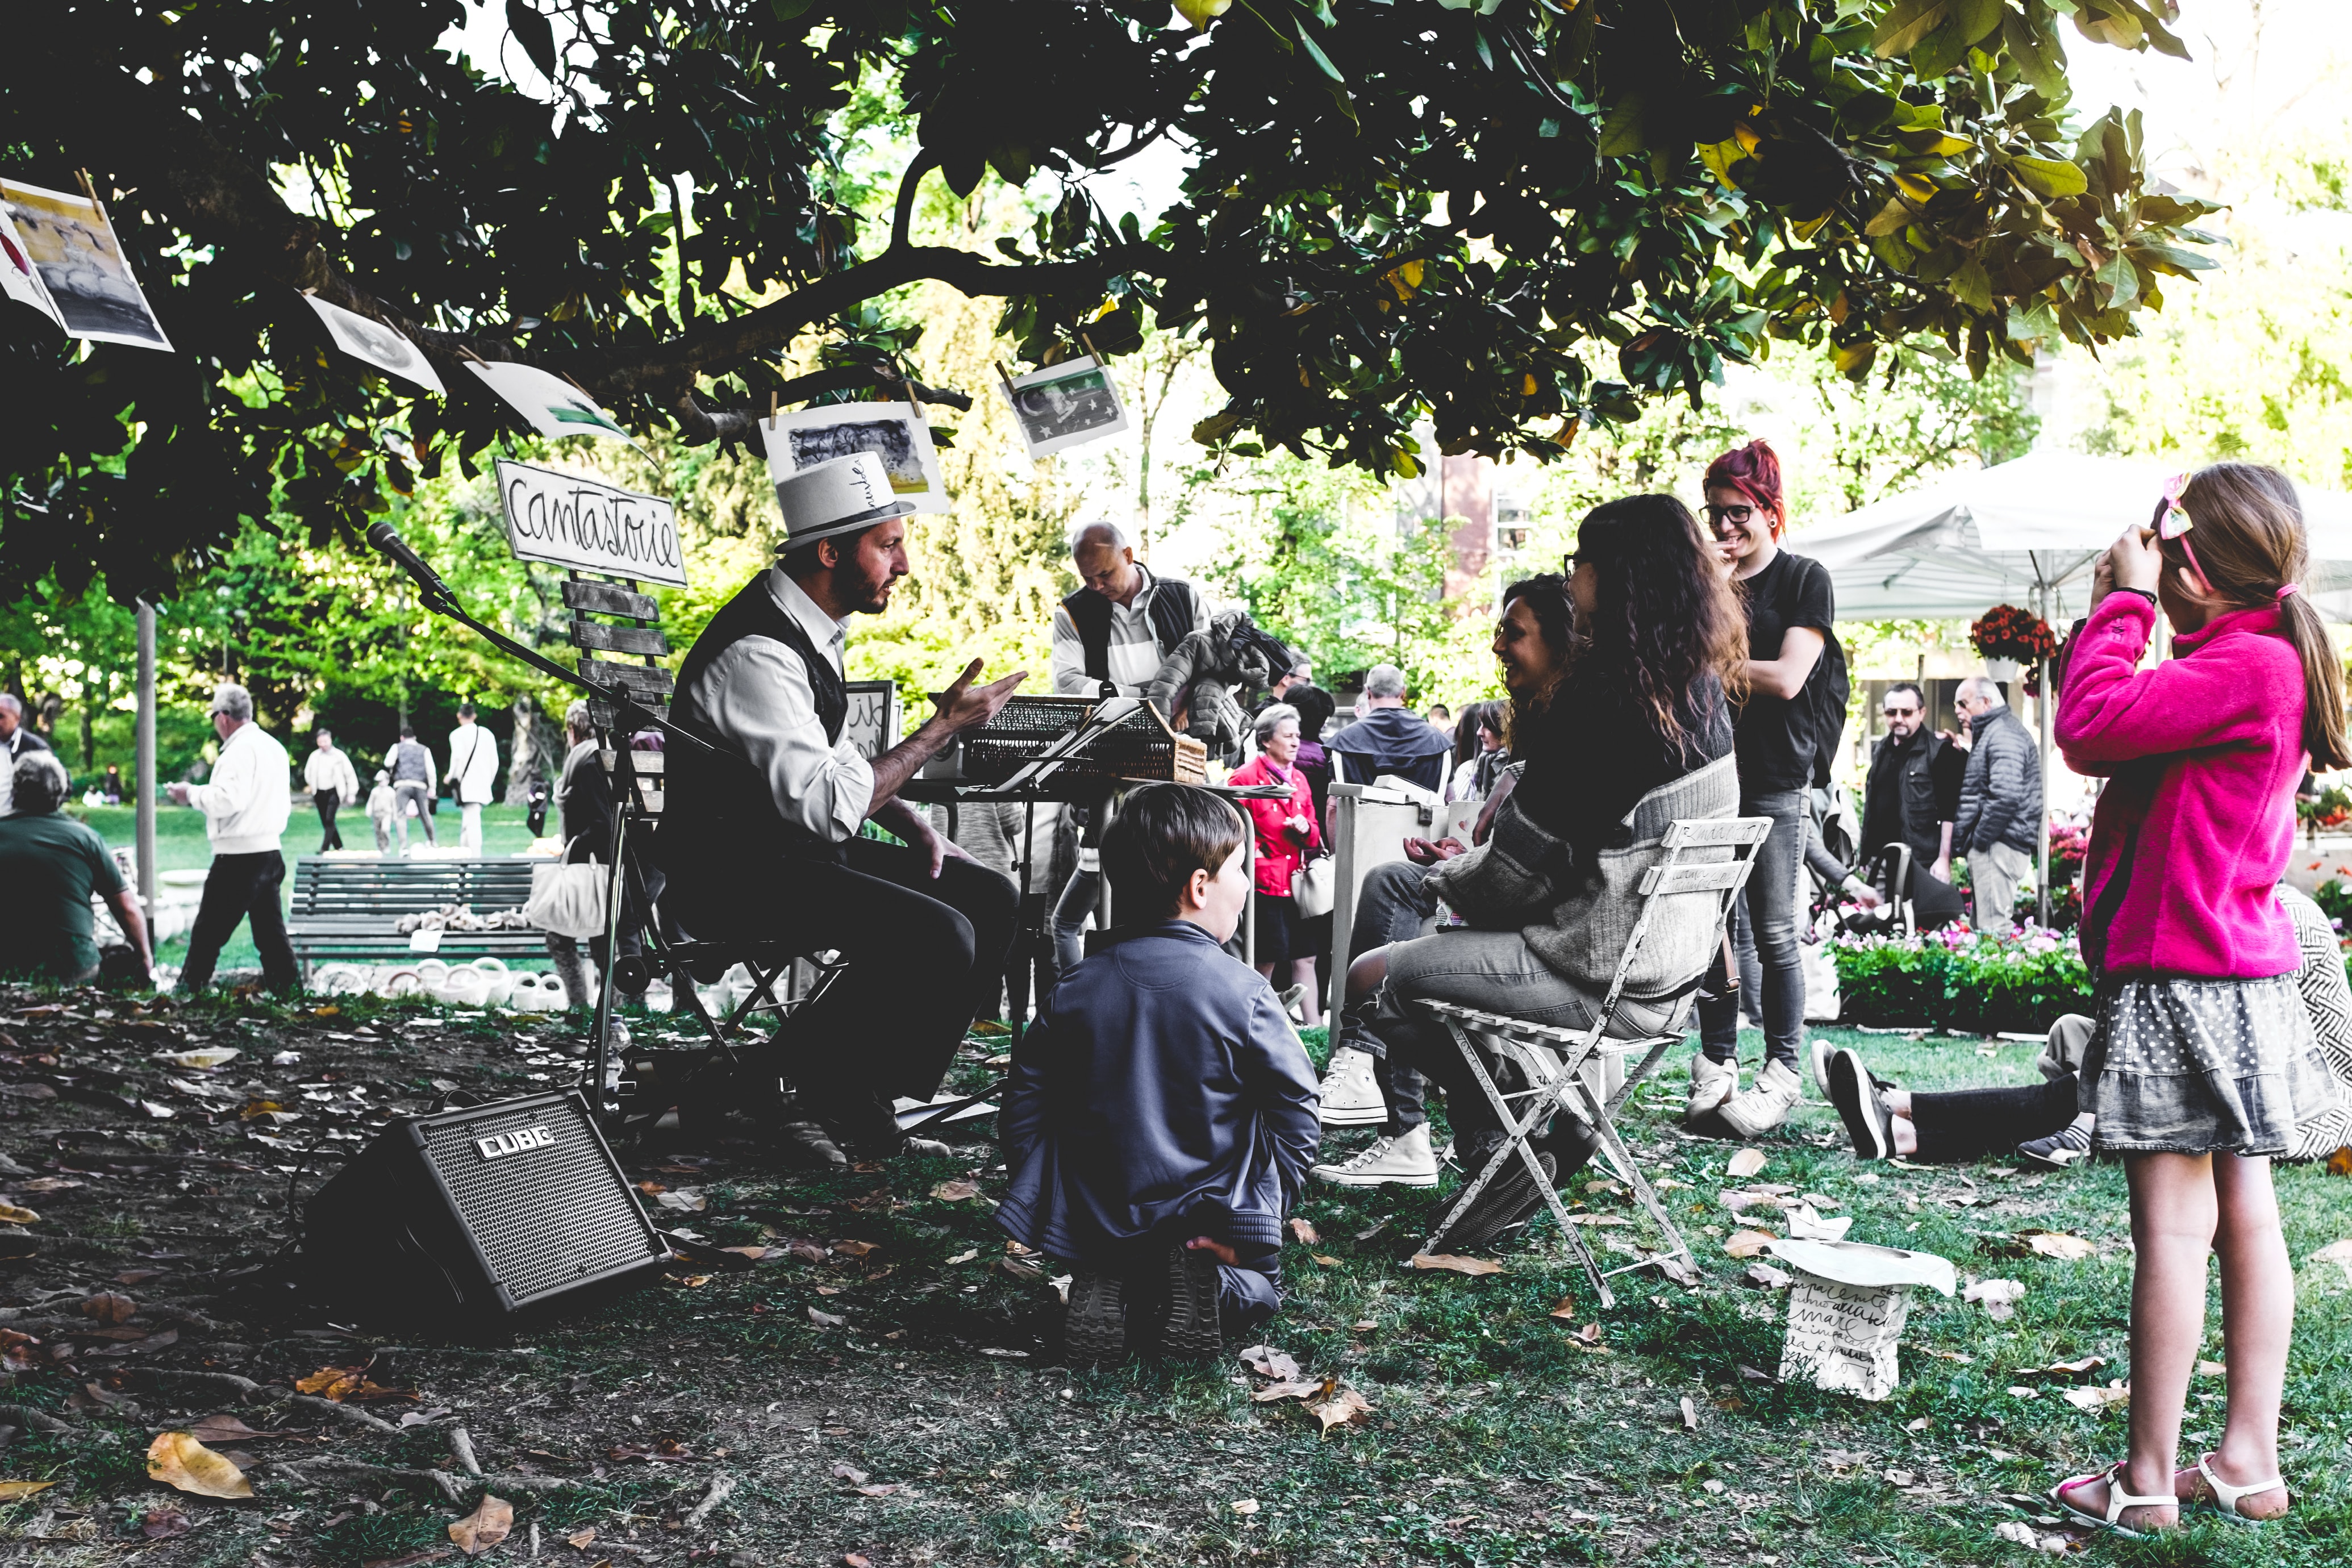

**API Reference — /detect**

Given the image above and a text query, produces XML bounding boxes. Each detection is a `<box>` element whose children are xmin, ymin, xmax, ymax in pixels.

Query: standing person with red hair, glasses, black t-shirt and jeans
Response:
<box><xmin>1686</xmin><ymin>442</ymin><xmax>1837</xmax><ymax>1138</ymax></box>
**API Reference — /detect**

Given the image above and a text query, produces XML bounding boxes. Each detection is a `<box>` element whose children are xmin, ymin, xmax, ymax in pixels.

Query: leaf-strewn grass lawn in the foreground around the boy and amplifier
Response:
<box><xmin>0</xmin><ymin>992</ymin><xmax>2352</xmax><ymax>1568</ymax></box>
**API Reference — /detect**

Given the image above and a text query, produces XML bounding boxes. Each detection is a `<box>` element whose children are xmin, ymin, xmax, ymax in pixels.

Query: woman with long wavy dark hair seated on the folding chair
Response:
<box><xmin>1326</xmin><ymin>496</ymin><xmax>1748</xmax><ymax>1246</ymax></box>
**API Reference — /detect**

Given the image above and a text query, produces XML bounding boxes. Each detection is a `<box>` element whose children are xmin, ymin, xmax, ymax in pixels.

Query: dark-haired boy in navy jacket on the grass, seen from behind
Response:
<box><xmin>997</xmin><ymin>785</ymin><xmax>1320</xmax><ymax>1363</ymax></box>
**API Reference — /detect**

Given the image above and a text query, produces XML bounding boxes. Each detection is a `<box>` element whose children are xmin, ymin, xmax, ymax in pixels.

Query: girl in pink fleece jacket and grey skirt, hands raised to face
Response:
<box><xmin>2051</xmin><ymin>463</ymin><xmax>2352</xmax><ymax>1535</ymax></box>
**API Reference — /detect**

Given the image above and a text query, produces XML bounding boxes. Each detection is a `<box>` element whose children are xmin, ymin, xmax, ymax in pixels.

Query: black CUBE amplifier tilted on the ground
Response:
<box><xmin>303</xmin><ymin>1091</ymin><xmax>670</xmax><ymax>1326</ymax></box>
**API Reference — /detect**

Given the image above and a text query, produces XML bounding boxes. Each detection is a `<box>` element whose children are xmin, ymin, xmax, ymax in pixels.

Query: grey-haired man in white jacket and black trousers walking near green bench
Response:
<box><xmin>172</xmin><ymin>686</ymin><xmax>301</xmax><ymax>994</ymax></box>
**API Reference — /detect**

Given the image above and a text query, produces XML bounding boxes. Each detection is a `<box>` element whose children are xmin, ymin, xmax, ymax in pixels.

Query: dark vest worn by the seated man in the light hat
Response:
<box><xmin>661</xmin><ymin>572</ymin><xmax>849</xmax><ymax>874</ymax></box>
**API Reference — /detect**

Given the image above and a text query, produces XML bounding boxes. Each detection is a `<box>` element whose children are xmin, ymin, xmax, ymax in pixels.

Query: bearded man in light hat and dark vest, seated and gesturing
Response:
<box><xmin>656</xmin><ymin>451</ymin><xmax>1028</xmax><ymax>1164</ymax></box>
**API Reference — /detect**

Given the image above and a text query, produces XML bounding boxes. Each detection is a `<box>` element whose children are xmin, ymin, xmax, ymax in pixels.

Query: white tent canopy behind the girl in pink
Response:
<box><xmin>1787</xmin><ymin>451</ymin><xmax>2352</xmax><ymax>635</ymax></box>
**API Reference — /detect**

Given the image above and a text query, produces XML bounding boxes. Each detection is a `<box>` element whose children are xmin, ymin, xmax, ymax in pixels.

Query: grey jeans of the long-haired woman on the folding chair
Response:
<box><xmin>1371</xmin><ymin>931</ymin><xmax>1679</xmax><ymax>1147</ymax></box>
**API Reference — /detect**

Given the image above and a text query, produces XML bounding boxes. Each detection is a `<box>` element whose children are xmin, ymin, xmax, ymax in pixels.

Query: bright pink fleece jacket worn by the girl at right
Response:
<box><xmin>2055</xmin><ymin>593</ymin><xmax>2305</xmax><ymax>981</ymax></box>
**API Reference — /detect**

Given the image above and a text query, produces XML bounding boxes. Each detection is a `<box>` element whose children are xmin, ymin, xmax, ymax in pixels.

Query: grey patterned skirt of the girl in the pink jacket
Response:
<box><xmin>2082</xmin><ymin>973</ymin><xmax>2342</xmax><ymax>1157</ymax></box>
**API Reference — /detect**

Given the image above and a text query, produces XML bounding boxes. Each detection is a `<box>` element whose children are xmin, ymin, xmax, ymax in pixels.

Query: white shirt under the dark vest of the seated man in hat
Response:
<box><xmin>679</xmin><ymin>566</ymin><xmax>875</xmax><ymax>844</ymax></box>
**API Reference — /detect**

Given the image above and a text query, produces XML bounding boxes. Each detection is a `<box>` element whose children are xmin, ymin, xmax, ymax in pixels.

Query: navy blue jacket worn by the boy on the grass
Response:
<box><xmin>997</xmin><ymin>919</ymin><xmax>1322</xmax><ymax>1269</ymax></box>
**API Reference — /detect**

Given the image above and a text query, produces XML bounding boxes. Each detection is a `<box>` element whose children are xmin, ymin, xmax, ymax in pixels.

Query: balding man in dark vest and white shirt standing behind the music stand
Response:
<box><xmin>1054</xmin><ymin>522</ymin><xmax>1209</xmax><ymax>973</ymax></box>
